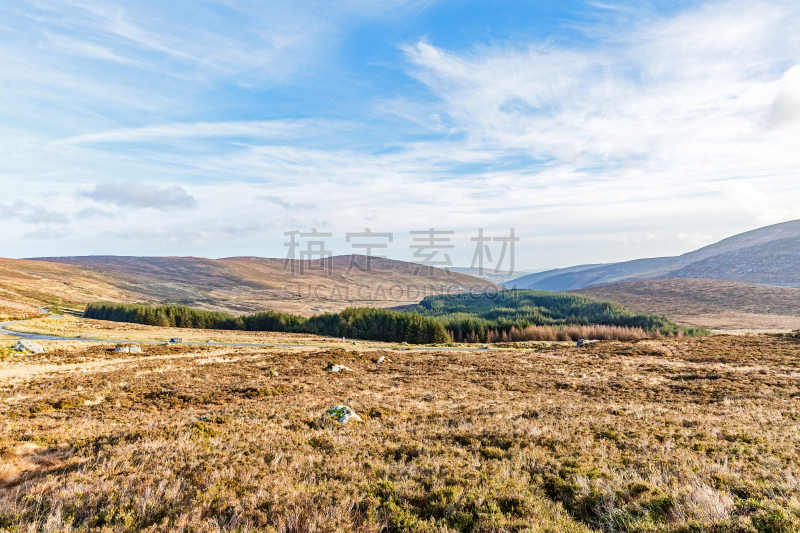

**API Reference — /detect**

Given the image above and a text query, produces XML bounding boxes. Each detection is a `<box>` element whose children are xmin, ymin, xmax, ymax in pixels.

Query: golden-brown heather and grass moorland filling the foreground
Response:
<box><xmin>0</xmin><ymin>330</ymin><xmax>800</xmax><ymax>533</ymax></box>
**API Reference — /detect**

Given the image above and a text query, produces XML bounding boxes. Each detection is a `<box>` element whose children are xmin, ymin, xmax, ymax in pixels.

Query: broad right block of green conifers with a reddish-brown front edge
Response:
<box><xmin>412</xmin><ymin>290</ymin><xmax>709</xmax><ymax>342</ymax></box>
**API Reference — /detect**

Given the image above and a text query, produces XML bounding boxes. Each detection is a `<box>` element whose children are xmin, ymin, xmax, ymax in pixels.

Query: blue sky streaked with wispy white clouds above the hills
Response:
<box><xmin>0</xmin><ymin>0</ymin><xmax>800</xmax><ymax>270</ymax></box>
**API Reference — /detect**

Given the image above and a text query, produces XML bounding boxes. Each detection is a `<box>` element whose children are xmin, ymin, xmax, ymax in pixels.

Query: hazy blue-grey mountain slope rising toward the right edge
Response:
<box><xmin>503</xmin><ymin>220</ymin><xmax>800</xmax><ymax>291</ymax></box>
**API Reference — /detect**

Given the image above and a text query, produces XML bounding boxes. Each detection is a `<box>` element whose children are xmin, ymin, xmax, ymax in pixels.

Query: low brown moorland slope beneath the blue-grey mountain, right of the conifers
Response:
<box><xmin>570</xmin><ymin>279</ymin><xmax>800</xmax><ymax>333</ymax></box>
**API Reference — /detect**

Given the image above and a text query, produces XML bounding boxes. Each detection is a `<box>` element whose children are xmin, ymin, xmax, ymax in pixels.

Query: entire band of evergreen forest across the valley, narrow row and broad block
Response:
<box><xmin>85</xmin><ymin>289</ymin><xmax>709</xmax><ymax>344</ymax></box>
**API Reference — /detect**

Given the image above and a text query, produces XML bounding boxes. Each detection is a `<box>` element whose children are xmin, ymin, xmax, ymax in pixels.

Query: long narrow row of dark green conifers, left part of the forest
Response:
<box><xmin>84</xmin><ymin>303</ymin><xmax>450</xmax><ymax>344</ymax></box>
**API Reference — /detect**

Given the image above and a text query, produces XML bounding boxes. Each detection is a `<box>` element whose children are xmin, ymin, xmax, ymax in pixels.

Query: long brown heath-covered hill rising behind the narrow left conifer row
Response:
<box><xmin>0</xmin><ymin>255</ymin><xmax>497</xmax><ymax>316</ymax></box>
